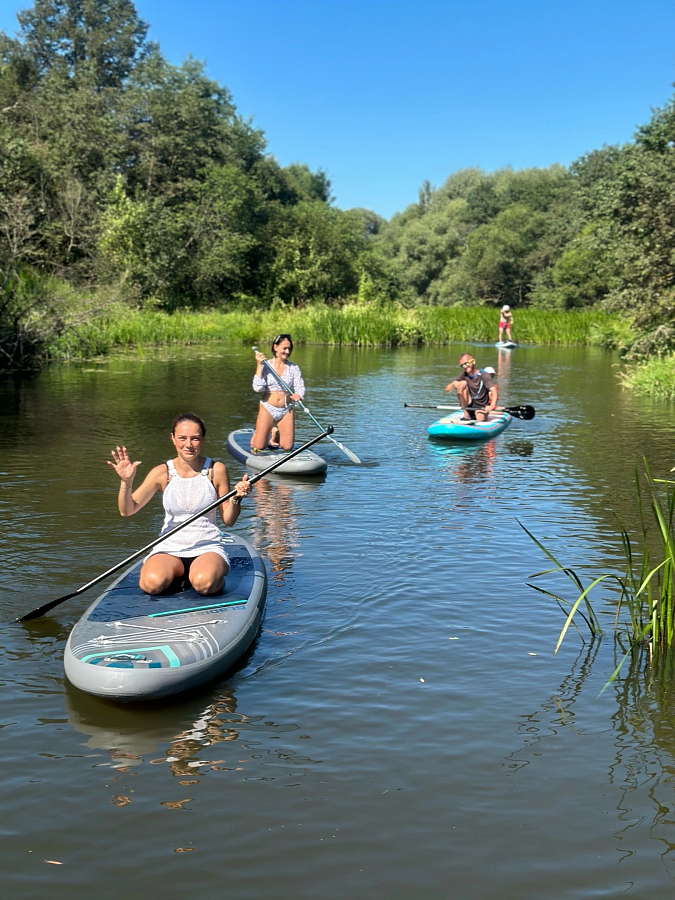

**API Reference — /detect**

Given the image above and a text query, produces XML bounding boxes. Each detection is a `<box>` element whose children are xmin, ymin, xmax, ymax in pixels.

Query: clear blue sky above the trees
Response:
<box><xmin>0</xmin><ymin>0</ymin><xmax>675</xmax><ymax>217</ymax></box>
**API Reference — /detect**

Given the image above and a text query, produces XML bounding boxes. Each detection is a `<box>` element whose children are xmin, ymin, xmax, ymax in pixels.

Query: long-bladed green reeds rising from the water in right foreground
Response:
<box><xmin>519</xmin><ymin>459</ymin><xmax>675</xmax><ymax>690</ymax></box>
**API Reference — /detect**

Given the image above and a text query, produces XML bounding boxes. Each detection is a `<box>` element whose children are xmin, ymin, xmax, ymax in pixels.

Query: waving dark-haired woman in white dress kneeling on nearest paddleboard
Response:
<box><xmin>107</xmin><ymin>413</ymin><xmax>251</xmax><ymax>595</ymax></box>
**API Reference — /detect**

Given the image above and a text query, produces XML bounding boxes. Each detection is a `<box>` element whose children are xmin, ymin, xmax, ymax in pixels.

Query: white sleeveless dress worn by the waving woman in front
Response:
<box><xmin>146</xmin><ymin>458</ymin><xmax>229</xmax><ymax>562</ymax></box>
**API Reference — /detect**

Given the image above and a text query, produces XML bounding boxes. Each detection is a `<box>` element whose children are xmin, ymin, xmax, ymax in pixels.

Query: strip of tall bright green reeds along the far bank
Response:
<box><xmin>49</xmin><ymin>305</ymin><xmax>622</xmax><ymax>359</ymax></box>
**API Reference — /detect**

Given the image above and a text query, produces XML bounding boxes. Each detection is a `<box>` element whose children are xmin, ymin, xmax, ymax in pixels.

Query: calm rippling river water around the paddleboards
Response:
<box><xmin>0</xmin><ymin>346</ymin><xmax>675</xmax><ymax>900</ymax></box>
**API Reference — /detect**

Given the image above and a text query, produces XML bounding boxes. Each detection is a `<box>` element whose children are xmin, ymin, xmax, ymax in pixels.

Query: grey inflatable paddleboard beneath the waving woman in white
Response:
<box><xmin>64</xmin><ymin>535</ymin><xmax>267</xmax><ymax>701</ymax></box>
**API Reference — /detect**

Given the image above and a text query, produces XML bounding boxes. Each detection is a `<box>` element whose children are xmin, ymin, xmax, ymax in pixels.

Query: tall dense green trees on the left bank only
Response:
<box><xmin>0</xmin><ymin>0</ymin><xmax>376</xmax><ymax>366</ymax></box>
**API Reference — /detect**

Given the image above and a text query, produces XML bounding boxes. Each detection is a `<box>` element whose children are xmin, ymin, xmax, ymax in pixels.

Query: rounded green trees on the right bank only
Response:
<box><xmin>374</xmin><ymin>110</ymin><xmax>675</xmax><ymax>356</ymax></box>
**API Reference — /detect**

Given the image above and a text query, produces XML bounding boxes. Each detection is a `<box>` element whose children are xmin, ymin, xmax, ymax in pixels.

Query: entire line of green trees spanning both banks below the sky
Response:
<box><xmin>0</xmin><ymin>0</ymin><xmax>675</xmax><ymax>369</ymax></box>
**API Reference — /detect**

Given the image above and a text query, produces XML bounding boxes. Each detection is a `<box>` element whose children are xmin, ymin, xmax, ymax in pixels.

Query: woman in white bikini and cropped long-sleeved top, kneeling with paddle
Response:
<box><xmin>251</xmin><ymin>334</ymin><xmax>305</xmax><ymax>453</ymax></box>
